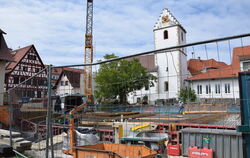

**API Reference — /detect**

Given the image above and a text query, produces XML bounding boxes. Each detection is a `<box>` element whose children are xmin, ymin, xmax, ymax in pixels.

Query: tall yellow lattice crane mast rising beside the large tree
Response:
<box><xmin>84</xmin><ymin>0</ymin><xmax>93</xmax><ymax>102</ymax></box>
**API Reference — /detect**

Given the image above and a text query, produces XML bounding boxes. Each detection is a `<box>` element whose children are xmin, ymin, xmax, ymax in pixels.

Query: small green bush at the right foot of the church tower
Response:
<box><xmin>178</xmin><ymin>87</ymin><xmax>196</xmax><ymax>102</ymax></box>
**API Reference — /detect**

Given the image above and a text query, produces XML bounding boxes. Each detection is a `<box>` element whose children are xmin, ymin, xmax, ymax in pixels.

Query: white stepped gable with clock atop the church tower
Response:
<box><xmin>154</xmin><ymin>8</ymin><xmax>186</xmax><ymax>32</ymax></box>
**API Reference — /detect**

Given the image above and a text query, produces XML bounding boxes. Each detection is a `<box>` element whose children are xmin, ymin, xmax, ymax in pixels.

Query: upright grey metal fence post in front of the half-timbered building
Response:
<box><xmin>46</xmin><ymin>65</ymin><xmax>54</xmax><ymax>158</ymax></box>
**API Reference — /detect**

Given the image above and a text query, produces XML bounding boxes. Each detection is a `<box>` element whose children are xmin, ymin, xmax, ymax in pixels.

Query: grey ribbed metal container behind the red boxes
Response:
<box><xmin>182</xmin><ymin>128</ymin><xmax>243</xmax><ymax>158</ymax></box>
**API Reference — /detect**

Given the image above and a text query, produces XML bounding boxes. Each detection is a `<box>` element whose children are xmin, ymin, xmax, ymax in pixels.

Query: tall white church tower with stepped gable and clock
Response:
<box><xmin>154</xmin><ymin>9</ymin><xmax>187</xmax><ymax>100</ymax></box>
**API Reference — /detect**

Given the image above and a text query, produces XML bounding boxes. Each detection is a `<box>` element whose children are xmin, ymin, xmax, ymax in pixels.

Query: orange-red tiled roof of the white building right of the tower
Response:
<box><xmin>186</xmin><ymin>46</ymin><xmax>250</xmax><ymax>81</ymax></box>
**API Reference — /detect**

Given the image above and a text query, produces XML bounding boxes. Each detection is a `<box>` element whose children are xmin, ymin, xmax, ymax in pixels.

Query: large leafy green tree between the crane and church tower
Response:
<box><xmin>95</xmin><ymin>54</ymin><xmax>157</xmax><ymax>104</ymax></box>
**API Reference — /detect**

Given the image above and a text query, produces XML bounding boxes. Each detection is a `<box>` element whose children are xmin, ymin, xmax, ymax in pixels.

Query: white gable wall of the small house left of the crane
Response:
<box><xmin>56</xmin><ymin>75</ymin><xmax>80</xmax><ymax>95</ymax></box>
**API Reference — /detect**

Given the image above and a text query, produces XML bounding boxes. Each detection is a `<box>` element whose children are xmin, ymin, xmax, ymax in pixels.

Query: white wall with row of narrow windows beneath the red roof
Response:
<box><xmin>190</xmin><ymin>78</ymin><xmax>239</xmax><ymax>99</ymax></box>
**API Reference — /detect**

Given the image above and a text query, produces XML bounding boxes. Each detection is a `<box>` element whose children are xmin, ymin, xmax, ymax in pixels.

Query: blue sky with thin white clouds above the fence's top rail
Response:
<box><xmin>0</xmin><ymin>0</ymin><xmax>250</xmax><ymax>65</ymax></box>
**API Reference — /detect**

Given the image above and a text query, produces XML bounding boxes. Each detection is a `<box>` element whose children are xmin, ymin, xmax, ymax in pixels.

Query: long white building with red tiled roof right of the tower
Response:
<box><xmin>186</xmin><ymin>46</ymin><xmax>250</xmax><ymax>104</ymax></box>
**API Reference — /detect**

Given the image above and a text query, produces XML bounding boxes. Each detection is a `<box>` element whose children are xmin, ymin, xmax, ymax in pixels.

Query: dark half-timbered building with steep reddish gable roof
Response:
<box><xmin>5</xmin><ymin>45</ymin><xmax>47</xmax><ymax>99</ymax></box>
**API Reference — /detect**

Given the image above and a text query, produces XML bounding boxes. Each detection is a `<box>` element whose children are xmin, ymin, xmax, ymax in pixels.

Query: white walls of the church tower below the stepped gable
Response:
<box><xmin>154</xmin><ymin>25</ymin><xmax>188</xmax><ymax>99</ymax></box>
